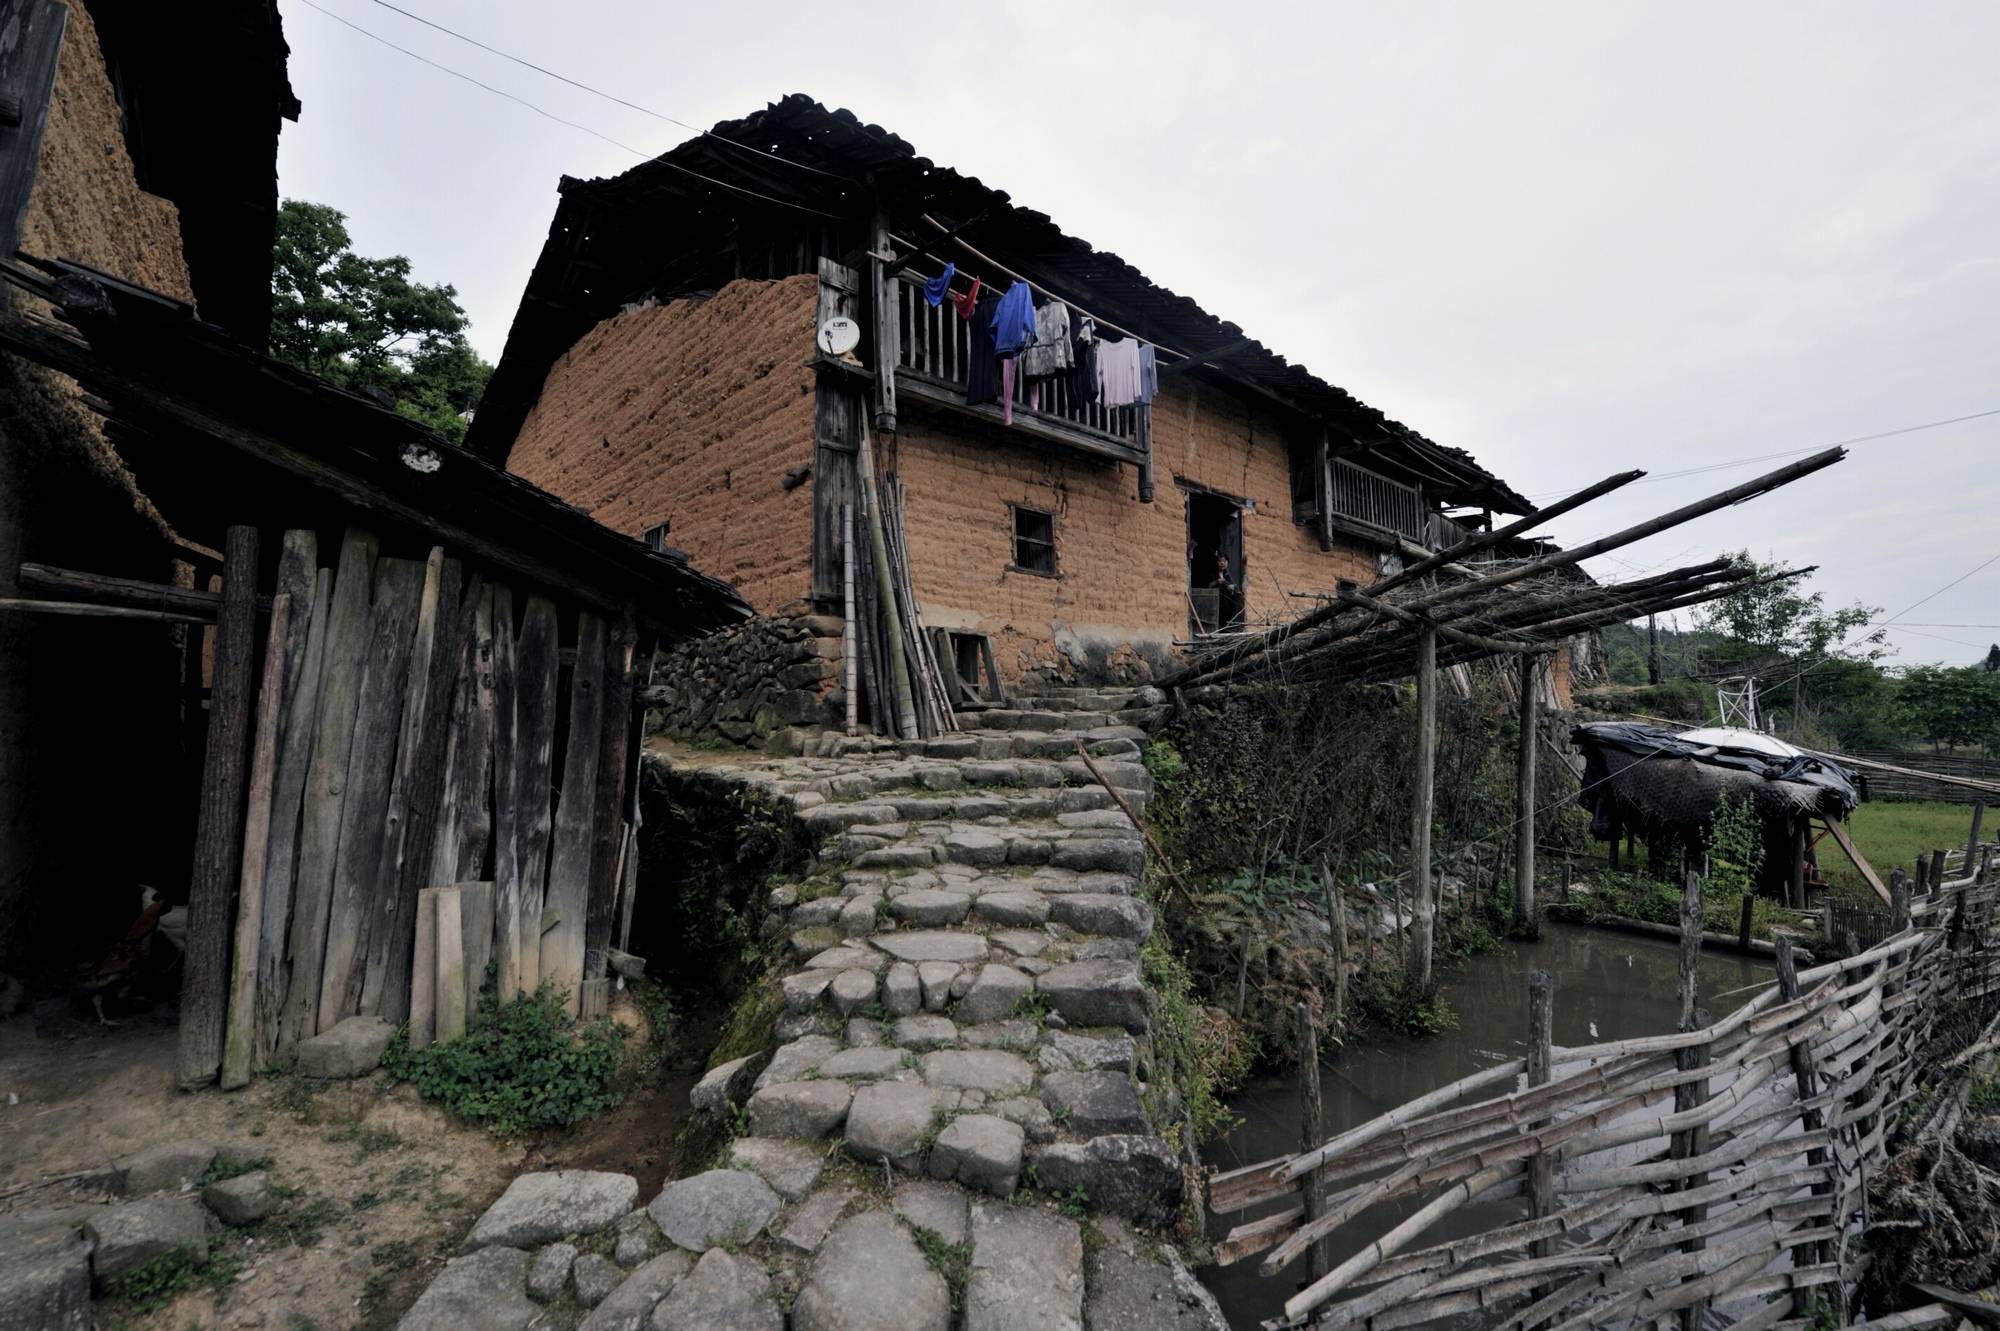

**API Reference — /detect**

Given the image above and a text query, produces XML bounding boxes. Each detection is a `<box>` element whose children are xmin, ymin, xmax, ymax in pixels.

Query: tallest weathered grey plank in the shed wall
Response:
<box><xmin>274</xmin><ymin>528</ymin><xmax>376</xmax><ymax>1059</ymax></box>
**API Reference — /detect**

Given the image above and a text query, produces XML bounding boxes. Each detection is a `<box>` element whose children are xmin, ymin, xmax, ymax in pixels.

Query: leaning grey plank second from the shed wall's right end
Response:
<box><xmin>542</xmin><ymin>610</ymin><xmax>606</xmax><ymax>1015</ymax></box>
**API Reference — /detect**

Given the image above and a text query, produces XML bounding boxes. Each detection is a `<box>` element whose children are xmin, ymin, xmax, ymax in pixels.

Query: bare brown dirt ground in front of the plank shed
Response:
<box><xmin>0</xmin><ymin>1001</ymin><xmax>698</xmax><ymax>1331</ymax></box>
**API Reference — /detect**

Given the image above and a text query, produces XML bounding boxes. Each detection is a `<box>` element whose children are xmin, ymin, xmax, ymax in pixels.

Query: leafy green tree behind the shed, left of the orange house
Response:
<box><xmin>270</xmin><ymin>198</ymin><xmax>492</xmax><ymax>444</ymax></box>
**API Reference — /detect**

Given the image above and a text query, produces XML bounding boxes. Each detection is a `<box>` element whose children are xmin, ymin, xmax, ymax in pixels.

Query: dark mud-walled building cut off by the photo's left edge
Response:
<box><xmin>0</xmin><ymin>0</ymin><xmax>298</xmax><ymax>973</ymax></box>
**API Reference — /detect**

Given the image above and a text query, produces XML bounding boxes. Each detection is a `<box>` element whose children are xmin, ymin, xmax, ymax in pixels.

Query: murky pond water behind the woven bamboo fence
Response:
<box><xmin>1200</xmin><ymin>925</ymin><xmax>1770</xmax><ymax>1331</ymax></box>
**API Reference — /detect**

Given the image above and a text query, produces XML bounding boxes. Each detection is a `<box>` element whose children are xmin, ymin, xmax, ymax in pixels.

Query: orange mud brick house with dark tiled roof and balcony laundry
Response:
<box><xmin>468</xmin><ymin>96</ymin><xmax>1532</xmax><ymax>715</ymax></box>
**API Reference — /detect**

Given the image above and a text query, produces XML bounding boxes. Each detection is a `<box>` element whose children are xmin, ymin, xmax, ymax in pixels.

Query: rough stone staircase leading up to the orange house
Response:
<box><xmin>390</xmin><ymin>691</ymin><xmax>1226</xmax><ymax>1331</ymax></box>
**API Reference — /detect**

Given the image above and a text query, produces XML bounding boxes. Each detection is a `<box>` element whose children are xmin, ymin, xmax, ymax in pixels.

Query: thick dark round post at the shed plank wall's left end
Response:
<box><xmin>176</xmin><ymin>526</ymin><xmax>256</xmax><ymax>1089</ymax></box>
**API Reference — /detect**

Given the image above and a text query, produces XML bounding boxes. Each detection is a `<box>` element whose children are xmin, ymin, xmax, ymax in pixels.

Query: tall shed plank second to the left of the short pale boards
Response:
<box><xmin>318</xmin><ymin>560</ymin><xmax>424</xmax><ymax>1031</ymax></box>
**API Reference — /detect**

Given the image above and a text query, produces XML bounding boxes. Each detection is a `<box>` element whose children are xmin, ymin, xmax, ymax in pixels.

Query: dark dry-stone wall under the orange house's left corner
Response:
<box><xmin>646</xmin><ymin>606</ymin><xmax>846</xmax><ymax>747</ymax></box>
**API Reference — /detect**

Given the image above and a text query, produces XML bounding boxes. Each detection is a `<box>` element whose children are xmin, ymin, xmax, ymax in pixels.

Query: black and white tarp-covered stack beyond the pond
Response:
<box><xmin>1570</xmin><ymin>721</ymin><xmax>1860</xmax><ymax>837</ymax></box>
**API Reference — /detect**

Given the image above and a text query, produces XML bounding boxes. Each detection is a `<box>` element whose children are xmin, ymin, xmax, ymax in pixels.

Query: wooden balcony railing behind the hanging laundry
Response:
<box><xmin>896</xmin><ymin>274</ymin><xmax>1150</xmax><ymax>462</ymax></box>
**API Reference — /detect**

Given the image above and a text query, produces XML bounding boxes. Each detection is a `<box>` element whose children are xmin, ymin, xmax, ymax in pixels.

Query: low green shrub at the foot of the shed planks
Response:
<box><xmin>382</xmin><ymin>985</ymin><xmax>624</xmax><ymax>1135</ymax></box>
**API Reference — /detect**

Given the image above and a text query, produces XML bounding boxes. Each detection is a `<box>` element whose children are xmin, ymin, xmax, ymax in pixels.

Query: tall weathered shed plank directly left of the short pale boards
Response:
<box><xmin>354</xmin><ymin>546</ymin><xmax>448</xmax><ymax>1019</ymax></box>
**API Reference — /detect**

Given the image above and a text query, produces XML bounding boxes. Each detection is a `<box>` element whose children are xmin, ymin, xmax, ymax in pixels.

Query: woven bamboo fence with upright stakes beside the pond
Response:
<box><xmin>1210</xmin><ymin>855</ymin><xmax>2000</xmax><ymax>1331</ymax></box>
